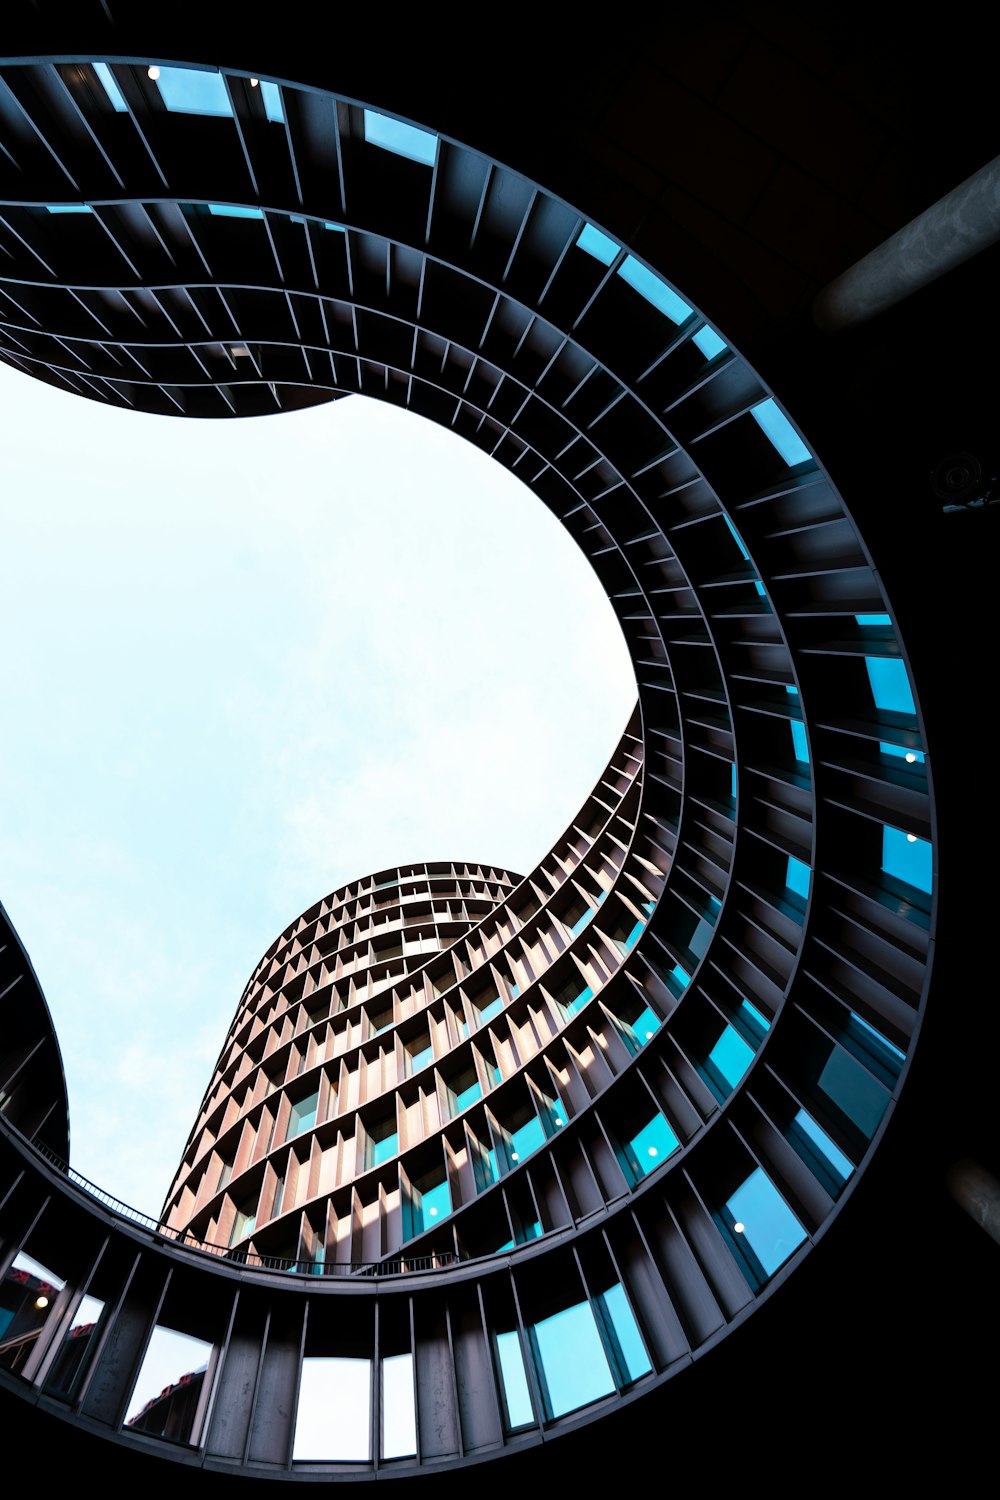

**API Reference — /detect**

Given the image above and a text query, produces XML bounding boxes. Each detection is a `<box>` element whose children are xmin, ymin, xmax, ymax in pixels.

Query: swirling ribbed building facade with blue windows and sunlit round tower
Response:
<box><xmin>0</xmin><ymin>6</ymin><xmax>995</xmax><ymax>1479</ymax></box>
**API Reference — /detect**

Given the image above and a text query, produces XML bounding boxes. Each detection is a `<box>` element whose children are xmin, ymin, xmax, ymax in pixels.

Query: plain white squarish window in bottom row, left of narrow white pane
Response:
<box><xmin>292</xmin><ymin>1358</ymin><xmax>372</xmax><ymax>1463</ymax></box>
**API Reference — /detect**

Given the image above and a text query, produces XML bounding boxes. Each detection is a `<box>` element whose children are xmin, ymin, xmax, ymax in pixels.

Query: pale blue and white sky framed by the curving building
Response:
<box><xmin>0</xmin><ymin>354</ymin><xmax>636</xmax><ymax>1215</ymax></box>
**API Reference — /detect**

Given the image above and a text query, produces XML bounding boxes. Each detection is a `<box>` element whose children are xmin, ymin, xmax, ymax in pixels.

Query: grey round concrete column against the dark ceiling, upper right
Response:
<box><xmin>813</xmin><ymin>156</ymin><xmax>1000</xmax><ymax>333</ymax></box>
